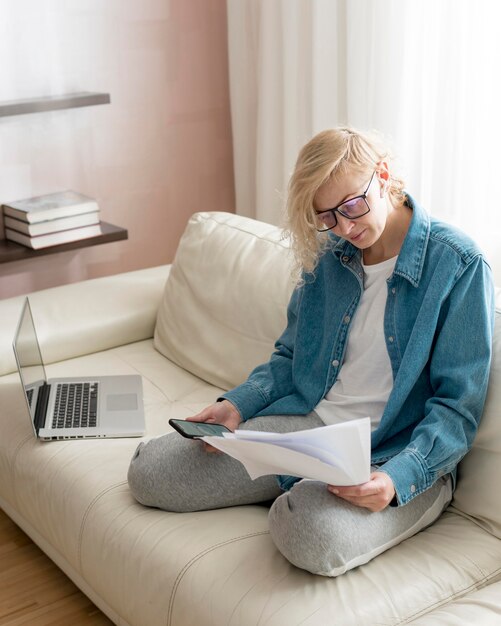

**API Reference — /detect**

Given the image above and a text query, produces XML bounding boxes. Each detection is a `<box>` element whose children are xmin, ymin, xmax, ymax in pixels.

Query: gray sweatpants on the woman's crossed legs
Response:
<box><xmin>128</xmin><ymin>413</ymin><xmax>452</xmax><ymax>576</ymax></box>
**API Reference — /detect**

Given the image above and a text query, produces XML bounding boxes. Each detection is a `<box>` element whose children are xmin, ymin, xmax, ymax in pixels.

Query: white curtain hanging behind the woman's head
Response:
<box><xmin>227</xmin><ymin>0</ymin><xmax>501</xmax><ymax>284</ymax></box>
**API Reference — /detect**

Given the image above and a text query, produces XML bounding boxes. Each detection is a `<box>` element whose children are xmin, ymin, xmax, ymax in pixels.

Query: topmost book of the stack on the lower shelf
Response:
<box><xmin>3</xmin><ymin>190</ymin><xmax>99</xmax><ymax>224</ymax></box>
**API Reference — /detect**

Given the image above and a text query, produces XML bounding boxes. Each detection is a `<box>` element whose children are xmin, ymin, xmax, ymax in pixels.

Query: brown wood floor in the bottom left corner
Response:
<box><xmin>0</xmin><ymin>509</ymin><xmax>112</xmax><ymax>626</ymax></box>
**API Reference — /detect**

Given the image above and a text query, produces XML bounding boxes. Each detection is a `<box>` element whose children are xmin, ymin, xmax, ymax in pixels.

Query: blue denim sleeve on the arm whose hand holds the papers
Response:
<box><xmin>379</xmin><ymin>256</ymin><xmax>494</xmax><ymax>504</ymax></box>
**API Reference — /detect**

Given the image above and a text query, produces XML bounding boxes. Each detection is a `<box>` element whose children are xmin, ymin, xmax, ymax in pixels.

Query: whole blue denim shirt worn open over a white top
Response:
<box><xmin>223</xmin><ymin>196</ymin><xmax>494</xmax><ymax>505</ymax></box>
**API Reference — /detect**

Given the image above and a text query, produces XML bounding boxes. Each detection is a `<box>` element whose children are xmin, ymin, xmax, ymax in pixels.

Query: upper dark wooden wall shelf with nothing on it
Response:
<box><xmin>0</xmin><ymin>91</ymin><xmax>111</xmax><ymax>117</ymax></box>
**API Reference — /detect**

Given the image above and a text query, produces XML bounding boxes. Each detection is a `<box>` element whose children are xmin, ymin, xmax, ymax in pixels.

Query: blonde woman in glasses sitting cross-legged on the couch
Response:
<box><xmin>129</xmin><ymin>128</ymin><xmax>493</xmax><ymax>576</ymax></box>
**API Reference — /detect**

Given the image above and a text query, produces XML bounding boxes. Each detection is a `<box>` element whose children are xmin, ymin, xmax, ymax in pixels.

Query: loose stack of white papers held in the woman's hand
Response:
<box><xmin>203</xmin><ymin>417</ymin><xmax>371</xmax><ymax>486</ymax></box>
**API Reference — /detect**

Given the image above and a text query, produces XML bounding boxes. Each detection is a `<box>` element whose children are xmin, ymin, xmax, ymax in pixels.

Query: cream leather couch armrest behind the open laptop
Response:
<box><xmin>0</xmin><ymin>265</ymin><xmax>170</xmax><ymax>376</ymax></box>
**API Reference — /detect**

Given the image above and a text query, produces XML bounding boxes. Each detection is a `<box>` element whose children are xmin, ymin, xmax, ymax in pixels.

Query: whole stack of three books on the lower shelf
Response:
<box><xmin>2</xmin><ymin>191</ymin><xmax>101</xmax><ymax>250</ymax></box>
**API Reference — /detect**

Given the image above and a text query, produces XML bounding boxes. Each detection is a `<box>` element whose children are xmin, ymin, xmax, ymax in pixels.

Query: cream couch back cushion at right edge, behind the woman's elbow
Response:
<box><xmin>453</xmin><ymin>292</ymin><xmax>501</xmax><ymax>539</ymax></box>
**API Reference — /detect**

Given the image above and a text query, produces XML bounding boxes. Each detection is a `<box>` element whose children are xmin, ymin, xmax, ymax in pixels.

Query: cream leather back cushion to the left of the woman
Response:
<box><xmin>154</xmin><ymin>212</ymin><xmax>293</xmax><ymax>389</ymax></box>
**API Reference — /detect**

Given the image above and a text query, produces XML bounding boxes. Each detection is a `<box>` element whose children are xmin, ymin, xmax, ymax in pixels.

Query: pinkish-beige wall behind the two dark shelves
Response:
<box><xmin>0</xmin><ymin>0</ymin><xmax>234</xmax><ymax>298</ymax></box>
